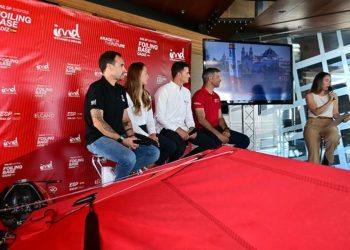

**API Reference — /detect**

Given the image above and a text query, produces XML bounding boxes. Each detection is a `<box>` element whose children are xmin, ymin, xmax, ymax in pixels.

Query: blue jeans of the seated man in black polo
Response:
<box><xmin>87</xmin><ymin>136</ymin><xmax>159</xmax><ymax>180</ymax></box>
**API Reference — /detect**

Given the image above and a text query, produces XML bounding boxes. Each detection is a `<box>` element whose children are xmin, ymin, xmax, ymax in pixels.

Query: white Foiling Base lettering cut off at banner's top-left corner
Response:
<box><xmin>0</xmin><ymin>5</ymin><xmax>32</xmax><ymax>33</ymax></box>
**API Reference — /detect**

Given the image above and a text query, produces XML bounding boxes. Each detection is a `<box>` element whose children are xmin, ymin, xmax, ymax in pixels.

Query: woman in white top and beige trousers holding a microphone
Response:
<box><xmin>304</xmin><ymin>72</ymin><xmax>340</xmax><ymax>165</ymax></box>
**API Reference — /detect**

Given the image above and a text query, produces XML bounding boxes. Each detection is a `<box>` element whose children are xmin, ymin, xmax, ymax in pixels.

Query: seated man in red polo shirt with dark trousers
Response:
<box><xmin>192</xmin><ymin>68</ymin><xmax>250</xmax><ymax>148</ymax></box>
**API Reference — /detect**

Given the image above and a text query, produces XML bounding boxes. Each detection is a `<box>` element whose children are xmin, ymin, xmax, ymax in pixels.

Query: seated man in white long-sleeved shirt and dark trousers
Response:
<box><xmin>155</xmin><ymin>62</ymin><xmax>206</xmax><ymax>161</ymax></box>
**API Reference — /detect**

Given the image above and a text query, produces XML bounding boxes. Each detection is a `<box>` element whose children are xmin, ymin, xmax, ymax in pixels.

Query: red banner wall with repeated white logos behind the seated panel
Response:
<box><xmin>0</xmin><ymin>0</ymin><xmax>191</xmax><ymax>197</ymax></box>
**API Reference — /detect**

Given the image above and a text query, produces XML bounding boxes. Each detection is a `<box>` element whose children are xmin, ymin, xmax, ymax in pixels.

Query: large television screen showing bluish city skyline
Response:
<box><xmin>203</xmin><ymin>39</ymin><xmax>294</xmax><ymax>104</ymax></box>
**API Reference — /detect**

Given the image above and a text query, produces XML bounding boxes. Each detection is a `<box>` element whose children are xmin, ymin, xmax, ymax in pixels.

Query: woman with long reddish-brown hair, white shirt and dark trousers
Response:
<box><xmin>126</xmin><ymin>62</ymin><xmax>176</xmax><ymax>165</ymax></box>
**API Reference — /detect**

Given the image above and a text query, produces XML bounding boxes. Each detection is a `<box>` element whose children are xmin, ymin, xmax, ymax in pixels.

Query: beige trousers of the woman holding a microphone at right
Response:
<box><xmin>304</xmin><ymin>117</ymin><xmax>340</xmax><ymax>165</ymax></box>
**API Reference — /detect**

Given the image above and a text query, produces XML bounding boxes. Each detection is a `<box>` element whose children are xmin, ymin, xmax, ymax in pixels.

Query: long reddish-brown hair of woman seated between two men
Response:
<box><xmin>125</xmin><ymin>62</ymin><xmax>152</xmax><ymax>114</ymax></box>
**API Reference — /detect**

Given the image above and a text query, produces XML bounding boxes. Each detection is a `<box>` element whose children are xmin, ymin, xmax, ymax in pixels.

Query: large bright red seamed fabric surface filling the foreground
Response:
<box><xmin>10</xmin><ymin>147</ymin><xmax>350</xmax><ymax>250</ymax></box>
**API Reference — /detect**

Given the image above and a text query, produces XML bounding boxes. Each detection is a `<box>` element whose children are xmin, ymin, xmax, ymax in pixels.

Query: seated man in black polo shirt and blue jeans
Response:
<box><xmin>84</xmin><ymin>51</ymin><xmax>159</xmax><ymax>180</ymax></box>
